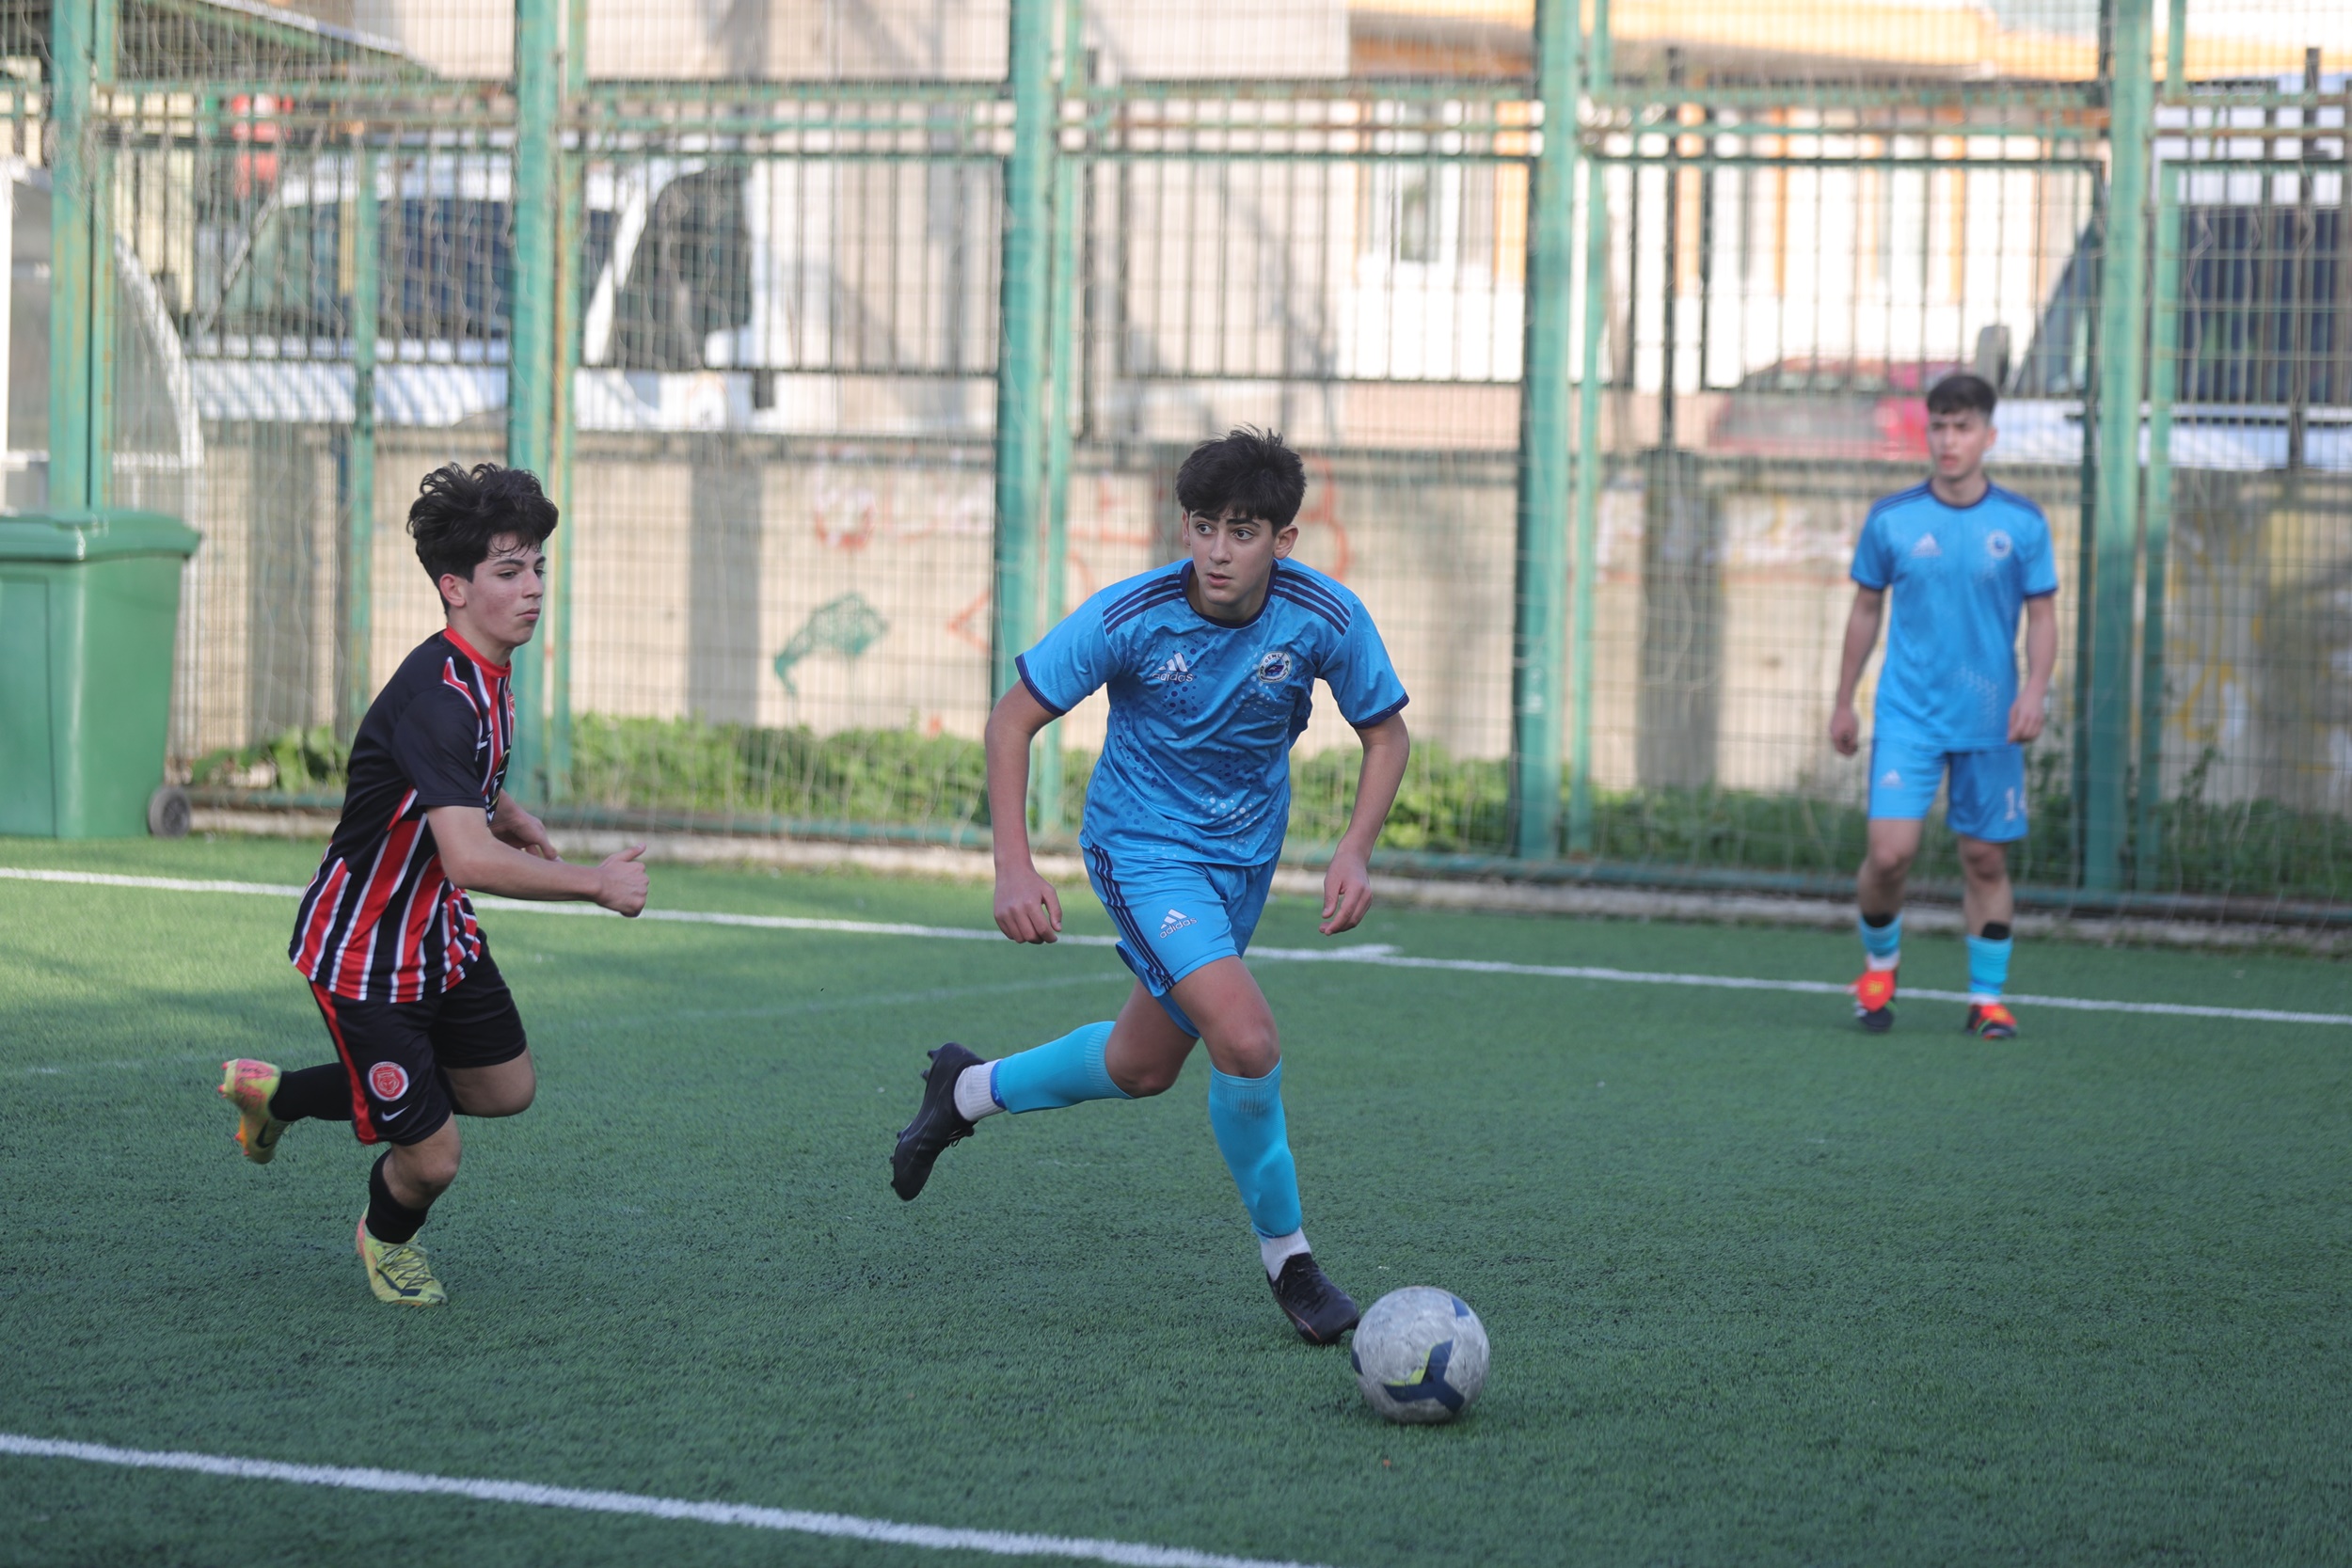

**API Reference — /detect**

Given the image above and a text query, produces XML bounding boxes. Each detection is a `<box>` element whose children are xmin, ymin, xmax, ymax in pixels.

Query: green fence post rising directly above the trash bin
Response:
<box><xmin>50</xmin><ymin>0</ymin><xmax>106</xmax><ymax>510</ymax></box>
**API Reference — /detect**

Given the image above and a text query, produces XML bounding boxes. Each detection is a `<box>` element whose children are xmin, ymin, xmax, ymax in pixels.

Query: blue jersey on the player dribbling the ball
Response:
<box><xmin>1019</xmin><ymin>562</ymin><xmax>1406</xmax><ymax>865</ymax></box>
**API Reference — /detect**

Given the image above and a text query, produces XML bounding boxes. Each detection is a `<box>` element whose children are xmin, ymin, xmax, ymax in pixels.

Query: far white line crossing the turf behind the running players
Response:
<box><xmin>0</xmin><ymin>865</ymin><xmax>2352</xmax><ymax>1025</ymax></box>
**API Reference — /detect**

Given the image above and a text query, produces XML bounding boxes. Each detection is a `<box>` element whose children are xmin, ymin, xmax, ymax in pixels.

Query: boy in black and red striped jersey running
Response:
<box><xmin>221</xmin><ymin>463</ymin><xmax>644</xmax><ymax>1307</ymax></box>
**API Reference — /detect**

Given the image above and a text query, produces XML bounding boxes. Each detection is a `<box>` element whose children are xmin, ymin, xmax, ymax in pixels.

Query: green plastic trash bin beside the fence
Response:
<box><xmin>0</xmin><ymin>513</ymin><xmax>198</xmax><ymax>839</ymax></box>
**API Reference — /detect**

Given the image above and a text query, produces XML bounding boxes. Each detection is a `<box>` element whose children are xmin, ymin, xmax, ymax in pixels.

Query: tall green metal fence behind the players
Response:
<box><xmin>18</xmin><ymin>0</ymin><xmax>2352</xmax><ymax>903</ymax></box>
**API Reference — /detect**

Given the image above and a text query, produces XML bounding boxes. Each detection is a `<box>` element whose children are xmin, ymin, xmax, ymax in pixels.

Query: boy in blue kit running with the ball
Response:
<box><xmin>892</xmin><ymin>430</ymin><xmax>1411</xmax><ymax>1345</ymax></box>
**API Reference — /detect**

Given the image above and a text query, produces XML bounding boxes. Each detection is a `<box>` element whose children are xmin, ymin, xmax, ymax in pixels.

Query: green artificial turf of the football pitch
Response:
<box><xmin>0</xmin><ymin>839</ymin><xmax>2352</xmax><ymax>1568</ymax></box>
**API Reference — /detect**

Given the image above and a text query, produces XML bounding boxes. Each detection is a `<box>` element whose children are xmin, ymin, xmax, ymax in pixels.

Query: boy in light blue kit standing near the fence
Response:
<box><xmin>1830</xmin><ymin>376</ymin><xmax>2058</xmax><ymax>1039</ymax></box>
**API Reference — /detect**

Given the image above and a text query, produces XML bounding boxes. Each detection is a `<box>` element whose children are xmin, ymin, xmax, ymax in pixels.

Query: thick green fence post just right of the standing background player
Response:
<box><xmin>2082</xmin><ymin>0</ymin><xmax>2154</xmax><ymax>891</ymax></box>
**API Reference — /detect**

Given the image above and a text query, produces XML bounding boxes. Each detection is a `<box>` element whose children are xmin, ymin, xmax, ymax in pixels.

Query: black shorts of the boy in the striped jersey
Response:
<box><xmin>310</xmin><ymin>952</ymin><xmax>530</xmax><ymax>1143</ymax></box>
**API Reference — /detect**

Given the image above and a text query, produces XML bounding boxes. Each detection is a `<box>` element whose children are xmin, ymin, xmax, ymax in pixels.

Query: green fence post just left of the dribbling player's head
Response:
<box><xmin>988</xmin><ymin>0</ymin><xmax>1057</xmax><ymax>701</ymax></box>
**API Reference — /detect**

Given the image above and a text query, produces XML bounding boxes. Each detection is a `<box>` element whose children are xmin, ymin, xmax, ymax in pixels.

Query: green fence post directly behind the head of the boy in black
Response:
<box><xmin>506</xmin><ymin>0</ymin><xmax>563</xmax><ymax>800</ymax></box>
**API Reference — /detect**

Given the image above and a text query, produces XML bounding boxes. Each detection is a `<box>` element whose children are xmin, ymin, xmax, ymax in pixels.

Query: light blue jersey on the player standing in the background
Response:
<box><xmin>1853</xmin><ymin>484</ymin><xmax>2058</xmax><ymax>752</ymax></box>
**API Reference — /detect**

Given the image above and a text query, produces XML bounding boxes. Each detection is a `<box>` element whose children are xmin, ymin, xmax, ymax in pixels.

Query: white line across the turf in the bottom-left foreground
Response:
<box><xmin>0</xmin><ymin>1432</ymin><xmax>1336</xmax><ymax>1568</ymax></box>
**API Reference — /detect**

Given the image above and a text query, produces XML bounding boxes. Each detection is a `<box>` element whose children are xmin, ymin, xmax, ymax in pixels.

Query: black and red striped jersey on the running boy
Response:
<box><xmin>287</xmin><ymin>630</ymin><xmax>516</xmax><ymax>1002</ymax></box>
